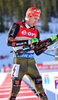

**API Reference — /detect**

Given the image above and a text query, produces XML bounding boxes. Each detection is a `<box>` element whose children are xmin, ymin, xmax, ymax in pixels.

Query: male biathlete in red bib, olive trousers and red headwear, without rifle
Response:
<box><xmin>7</xmin><ymin>7</ymin><xmax>56</xmax><ymax>100</ymax></box>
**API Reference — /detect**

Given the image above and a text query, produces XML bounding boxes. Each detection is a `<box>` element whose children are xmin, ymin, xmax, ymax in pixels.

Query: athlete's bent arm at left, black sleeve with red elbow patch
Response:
<box><xmin>7</xmin><ymin>23</ymin><xmax>28</xmax><ymax>47</ymax></box>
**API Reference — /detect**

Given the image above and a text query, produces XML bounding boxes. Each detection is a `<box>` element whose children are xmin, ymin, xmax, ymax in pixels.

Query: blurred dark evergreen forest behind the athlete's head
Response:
<box><xmin>0</xmin><ymin>0</ymin><xmax>58</xmax><ymax>32</ymax></box>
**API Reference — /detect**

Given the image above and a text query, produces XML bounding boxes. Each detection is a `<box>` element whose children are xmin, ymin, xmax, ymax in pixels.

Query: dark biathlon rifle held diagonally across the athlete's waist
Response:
<box><xmin>11</xmin><ymin>35</ymin><xmax>58</xmax><ymax>57</ymax></box>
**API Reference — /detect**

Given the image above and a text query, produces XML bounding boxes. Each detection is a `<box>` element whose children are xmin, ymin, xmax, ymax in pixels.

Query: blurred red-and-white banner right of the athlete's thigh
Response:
<box><xmin>36</xmin><ymin>63</ymin><xmax>58</xmax><ymax>70</ymax></box>
